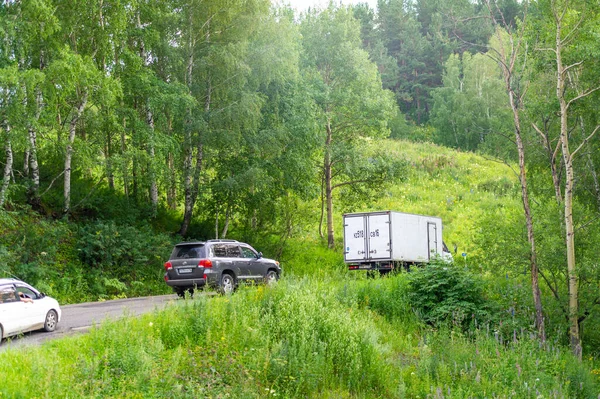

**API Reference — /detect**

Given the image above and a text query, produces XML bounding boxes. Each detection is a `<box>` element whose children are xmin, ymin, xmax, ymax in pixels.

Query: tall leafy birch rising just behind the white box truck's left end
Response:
<box><xmin>301</xmin><ymin>6</ymin><xmax>396</xmax><ymax>248</ymax></box>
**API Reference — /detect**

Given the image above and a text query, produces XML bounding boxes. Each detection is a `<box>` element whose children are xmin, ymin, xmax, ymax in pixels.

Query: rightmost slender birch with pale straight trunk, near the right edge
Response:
<box><xmin>537</xmin><ymin>0</ymin><xmax>600</xmax><ymax>359</ymax></box>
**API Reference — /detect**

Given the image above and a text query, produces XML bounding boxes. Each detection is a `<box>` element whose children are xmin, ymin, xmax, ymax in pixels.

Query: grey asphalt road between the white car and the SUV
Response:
<box><xmin>0</xmin><ymin>294</ymin><xmax>177</xmax><ymax>351</ymax></box>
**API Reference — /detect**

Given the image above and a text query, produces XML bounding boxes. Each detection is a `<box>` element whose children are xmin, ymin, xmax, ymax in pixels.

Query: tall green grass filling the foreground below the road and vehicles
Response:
<box><xmin>0</xmin><ymin>274</ymin><xmax>600</xmax><ymax>398</ymax></box>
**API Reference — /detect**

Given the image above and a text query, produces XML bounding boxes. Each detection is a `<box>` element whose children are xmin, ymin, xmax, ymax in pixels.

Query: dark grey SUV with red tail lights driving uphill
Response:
<box><xmin>165</xmin><ymin>240</ymin><xmax>281</xmax><ymax>297</ymax></box>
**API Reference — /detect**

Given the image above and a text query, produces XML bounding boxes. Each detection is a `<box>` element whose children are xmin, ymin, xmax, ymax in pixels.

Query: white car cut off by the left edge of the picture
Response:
<box><xmin>0</xmin><ymin>278</ymin><xmax>61</xmax><ymax>342</ymax></box>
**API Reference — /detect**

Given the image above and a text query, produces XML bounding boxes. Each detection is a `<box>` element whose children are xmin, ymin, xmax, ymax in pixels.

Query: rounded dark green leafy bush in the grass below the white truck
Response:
<box><xmin>408</xmin><ymin>262</ymin><xmax>492</xmax><ymax>331</ymax></box>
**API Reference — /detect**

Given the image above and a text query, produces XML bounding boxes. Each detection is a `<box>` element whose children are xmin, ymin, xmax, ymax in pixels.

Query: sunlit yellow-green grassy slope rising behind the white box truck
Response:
<box><xmin>282</xmin><ymin>140</ymin><xmax>528</xmax><ymax>273</ymax></box>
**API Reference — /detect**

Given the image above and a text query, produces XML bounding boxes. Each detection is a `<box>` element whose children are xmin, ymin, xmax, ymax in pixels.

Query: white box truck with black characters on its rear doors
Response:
<box><xmin>344</xmin><ymin>211</ymin><xmax>452</xmax><ymax>273</ymax></box>
